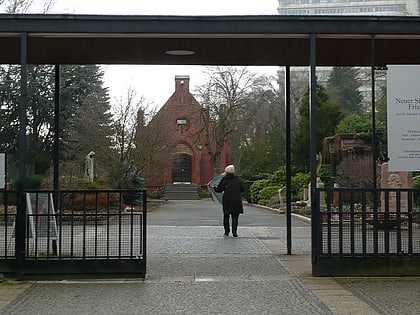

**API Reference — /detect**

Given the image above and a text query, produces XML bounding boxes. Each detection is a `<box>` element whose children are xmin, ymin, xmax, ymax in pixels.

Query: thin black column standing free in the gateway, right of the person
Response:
<box><xmin>284</xmin><ymin>66</ymin><xmax>292</xmax><ymax>255</ymax></box>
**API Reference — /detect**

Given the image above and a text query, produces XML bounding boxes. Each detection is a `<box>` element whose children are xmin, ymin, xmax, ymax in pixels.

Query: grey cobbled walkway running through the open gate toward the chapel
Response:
<box><xmin>0</xmin><ymin>201</ymin><xmax>420</xmax><ymax>315</ymax></box>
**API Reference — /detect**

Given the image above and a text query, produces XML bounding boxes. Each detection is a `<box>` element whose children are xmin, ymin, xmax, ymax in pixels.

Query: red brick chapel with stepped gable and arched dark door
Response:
<box><xmin>139</xmin><ymin>75</ymin><xmax>229</xmax><ymax>190</ymax></box>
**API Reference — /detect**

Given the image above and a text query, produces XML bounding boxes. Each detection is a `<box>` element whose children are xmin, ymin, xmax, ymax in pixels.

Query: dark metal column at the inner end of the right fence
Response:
<box><xmin>309</xmin><ymin>33</ymin><xmax>320</xmax><ymax>275</ymax></box>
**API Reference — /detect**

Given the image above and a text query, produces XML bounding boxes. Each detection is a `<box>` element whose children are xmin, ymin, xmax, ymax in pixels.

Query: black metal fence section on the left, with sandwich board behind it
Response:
<box><xmin>0</xmin><ymin>190</ymin><xmax>147</xmax><ymax>279</ymax></box>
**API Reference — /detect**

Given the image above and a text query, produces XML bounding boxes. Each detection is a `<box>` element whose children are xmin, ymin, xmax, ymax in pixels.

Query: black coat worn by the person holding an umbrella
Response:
<box><xmin>215</xmin><ymin>174</ymin><xmax>245</xmax><ymax>214</ymax></box>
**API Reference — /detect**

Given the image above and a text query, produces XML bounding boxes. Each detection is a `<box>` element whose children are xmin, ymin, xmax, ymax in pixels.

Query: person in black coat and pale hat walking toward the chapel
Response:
<box><xmin>215</xmin><ymin>165</ymin><xmax>245</xmax><ymax>237</ymax></box>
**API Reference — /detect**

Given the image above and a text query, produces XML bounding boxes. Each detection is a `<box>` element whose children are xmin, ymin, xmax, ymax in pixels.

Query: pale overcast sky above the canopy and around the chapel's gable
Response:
<box><xmin>46</xmin><ymin>0</ymin><xmax>278</xmax><ymax>108</ymax></box>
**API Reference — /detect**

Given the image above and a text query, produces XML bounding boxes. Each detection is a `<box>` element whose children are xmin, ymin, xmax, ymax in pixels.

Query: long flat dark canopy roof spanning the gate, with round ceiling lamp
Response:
<box><xmin>0</xmin><ymin>14</ymin><xmax>420</xmax><ymax>66</ymax></box>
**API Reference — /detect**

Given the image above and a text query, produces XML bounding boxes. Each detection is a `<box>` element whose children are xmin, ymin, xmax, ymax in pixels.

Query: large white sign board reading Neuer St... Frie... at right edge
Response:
<box><xmin>387</xmin><ymin>65</ymin><xmax>420</xmax><ymax>171</ymax></box>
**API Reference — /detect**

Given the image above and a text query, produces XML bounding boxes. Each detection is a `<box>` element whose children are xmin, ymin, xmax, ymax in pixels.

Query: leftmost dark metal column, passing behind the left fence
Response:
<box><xmin>15</xmin><ymin>32</ymin><xmax>28</xmax><ymax>280</ymax></box>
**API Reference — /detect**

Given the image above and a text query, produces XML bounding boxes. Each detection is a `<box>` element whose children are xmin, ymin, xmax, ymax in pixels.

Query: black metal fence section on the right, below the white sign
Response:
<box><xmin>312</xmin><ymin>188</ymin><xmax>420</xmax><ymax>276</ymax></box>
